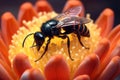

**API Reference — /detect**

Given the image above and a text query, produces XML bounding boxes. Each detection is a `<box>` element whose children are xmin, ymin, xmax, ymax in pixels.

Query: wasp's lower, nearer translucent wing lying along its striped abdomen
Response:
<box><xmin>56</xmin><ymin>16</ymin><xmax>91</xmax><ymax>28</ymax></box>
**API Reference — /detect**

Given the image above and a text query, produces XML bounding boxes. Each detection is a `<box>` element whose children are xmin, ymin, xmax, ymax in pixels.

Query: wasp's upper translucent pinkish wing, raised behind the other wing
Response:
<box><xmin>54</xmin><ymin>6</ymin><xmax>82</xmax><ymax>21</ymax></box>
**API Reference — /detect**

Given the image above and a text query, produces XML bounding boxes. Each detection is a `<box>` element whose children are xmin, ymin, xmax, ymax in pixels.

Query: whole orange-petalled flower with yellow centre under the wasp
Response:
<box><xmin>0</xmin><ymin>0</ymin><xmax>120</xmax><ymax>80</ymax></box>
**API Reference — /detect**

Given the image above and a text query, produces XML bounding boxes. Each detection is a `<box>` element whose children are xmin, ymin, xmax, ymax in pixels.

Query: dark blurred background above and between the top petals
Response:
<box><xmin>0</xmin><ymin>0</ymin><xmax>120</xmax><ymax>26</ymax></box>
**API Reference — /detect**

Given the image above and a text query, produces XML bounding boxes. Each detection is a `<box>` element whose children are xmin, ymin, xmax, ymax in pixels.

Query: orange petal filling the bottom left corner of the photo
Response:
<box><xmin>0</xmin><ymin>59</ymin><xmax>16</xmax><ymax>80</ymax></box>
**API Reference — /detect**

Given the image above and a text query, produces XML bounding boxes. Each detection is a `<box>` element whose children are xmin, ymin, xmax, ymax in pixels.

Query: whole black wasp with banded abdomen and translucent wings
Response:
<box><xmin>22</xmin><ymin>6</ymin><xmax>90</xmax><ymax>62</ymax></box>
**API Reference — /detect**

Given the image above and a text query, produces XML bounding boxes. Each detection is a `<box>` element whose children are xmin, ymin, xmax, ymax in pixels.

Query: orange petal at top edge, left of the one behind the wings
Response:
<box><xmin>35</xmin><ymin>0</ymin><xmax>53</xmax><ymax>12</ymax></box>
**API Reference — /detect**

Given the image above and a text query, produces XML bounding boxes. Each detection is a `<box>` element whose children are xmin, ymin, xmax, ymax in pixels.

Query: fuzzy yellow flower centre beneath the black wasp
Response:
<box><xmin>9</xmin><ymin>12</ymin><xmax>100</xmax><ymax>73</ymax></box>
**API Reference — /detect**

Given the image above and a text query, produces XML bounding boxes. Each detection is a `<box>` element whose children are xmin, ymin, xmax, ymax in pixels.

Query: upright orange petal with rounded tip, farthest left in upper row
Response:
<box><xmin>1</xmin><ymin>12</ymin><xmax>19</xmax><ymax>46</ymax></box>
